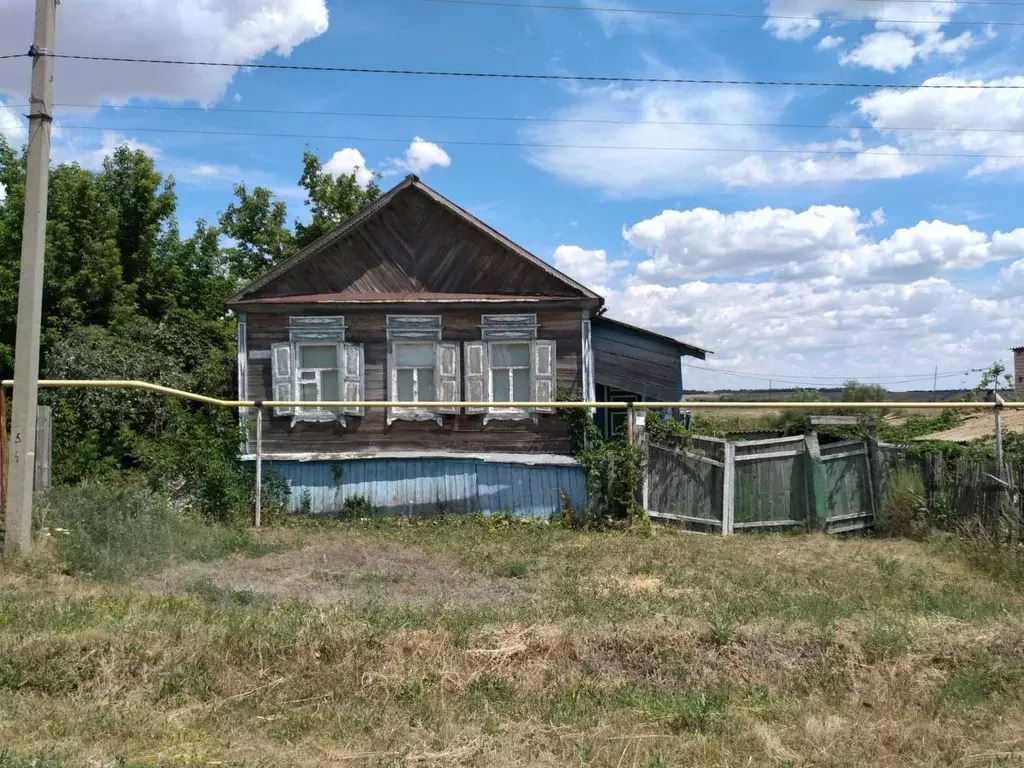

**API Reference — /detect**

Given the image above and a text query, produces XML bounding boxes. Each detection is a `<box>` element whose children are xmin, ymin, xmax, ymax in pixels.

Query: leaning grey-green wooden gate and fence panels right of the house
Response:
<box><xmin>644</xmin><ymin>433</ymin><xmax>882</xmax><ymax>534</ymax></box>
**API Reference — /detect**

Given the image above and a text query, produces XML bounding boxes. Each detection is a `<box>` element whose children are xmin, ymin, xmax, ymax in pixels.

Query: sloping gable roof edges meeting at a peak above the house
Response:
<box><xmin>227</xmin><ymin>174</ymin><xmax>604</xmax><ymax>305</ymax></box>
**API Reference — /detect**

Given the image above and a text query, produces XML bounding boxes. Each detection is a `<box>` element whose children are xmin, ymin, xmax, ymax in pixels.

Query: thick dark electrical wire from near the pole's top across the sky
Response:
<box><xmin>34</xmin><ymin>52</ymin><xmax>1024</xmax><ymax>90</ymax></box>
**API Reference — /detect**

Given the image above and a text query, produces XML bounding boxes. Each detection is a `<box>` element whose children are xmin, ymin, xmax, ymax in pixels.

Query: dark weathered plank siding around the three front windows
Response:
<box><xmin>243</xmin><ymin>306</ymin><xmax>583</xmax><ymax>455</ymax></box>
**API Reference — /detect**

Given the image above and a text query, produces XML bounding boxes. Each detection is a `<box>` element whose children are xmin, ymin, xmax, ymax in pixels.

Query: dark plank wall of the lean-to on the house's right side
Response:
<box><xmin>592</xmin><ymin>322</ymin><xmax>682</xmax><ymax>401</ymax></box>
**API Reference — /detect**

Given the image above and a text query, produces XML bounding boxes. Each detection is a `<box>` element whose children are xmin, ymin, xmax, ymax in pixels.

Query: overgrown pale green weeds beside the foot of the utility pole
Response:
<box><xmin>39</xmin><ymin>482</ymin><xmax>265</xmax><ymax>580</ymax></box>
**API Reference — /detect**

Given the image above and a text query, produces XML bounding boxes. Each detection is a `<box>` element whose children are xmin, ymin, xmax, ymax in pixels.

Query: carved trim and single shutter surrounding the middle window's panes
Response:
<box><xmin>387</xmin><ymin>314</ymin><xmax>462</xmax><ymax>426</ymax></box>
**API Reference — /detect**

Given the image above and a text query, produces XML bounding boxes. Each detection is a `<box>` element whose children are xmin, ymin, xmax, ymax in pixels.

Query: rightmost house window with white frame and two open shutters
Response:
<box><xmin>465</xmin><ymin>314</ymin><xmax>556</xmax><ymax>423</ymax></box>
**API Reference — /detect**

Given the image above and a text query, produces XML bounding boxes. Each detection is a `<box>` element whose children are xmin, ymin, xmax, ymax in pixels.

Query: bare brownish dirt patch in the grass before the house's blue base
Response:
<box><xmin>139</xmin><ymin>531</ymin><xmax>536</xmax><ymax>605</ymax></box>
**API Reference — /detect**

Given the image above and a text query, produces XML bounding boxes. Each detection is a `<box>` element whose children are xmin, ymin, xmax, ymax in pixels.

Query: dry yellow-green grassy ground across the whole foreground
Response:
<box><xmin>0</xmin><ymin>518</ymin><xmax>1024</xmax><ymax>768</ymax></box>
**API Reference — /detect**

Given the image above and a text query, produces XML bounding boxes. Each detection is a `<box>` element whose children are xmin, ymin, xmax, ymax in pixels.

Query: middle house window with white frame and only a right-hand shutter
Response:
<box><xmin>387</xmin><ymin>314</ymin><xmax>461</xmax><ymax>424</ymax></box>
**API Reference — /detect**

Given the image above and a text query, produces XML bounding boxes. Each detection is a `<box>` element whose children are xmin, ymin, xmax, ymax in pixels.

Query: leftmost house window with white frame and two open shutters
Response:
<box><xmin>270</xmin><ymin>316</ymin><xmax>366</xmax><ymax>425</ymax></box>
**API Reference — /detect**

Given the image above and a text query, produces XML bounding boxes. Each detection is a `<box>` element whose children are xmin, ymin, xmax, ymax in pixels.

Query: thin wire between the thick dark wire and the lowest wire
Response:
<box><xmin>6</xmin><ymin>103</ymin><xmax>1024</xmax><ymax>133</ymax></box>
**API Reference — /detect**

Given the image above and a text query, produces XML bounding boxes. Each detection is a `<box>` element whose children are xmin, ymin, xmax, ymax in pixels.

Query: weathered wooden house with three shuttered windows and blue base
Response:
<box><xmin>228</xmin><ymin>176</ymin><xmax>705</xmax><ymax>514</ymax></box>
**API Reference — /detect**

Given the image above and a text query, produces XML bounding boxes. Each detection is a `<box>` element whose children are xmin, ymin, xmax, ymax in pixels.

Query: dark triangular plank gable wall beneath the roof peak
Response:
<box><xmin>246</xmin><ymin>187</ymin><xmax>581</xmax><ymax>300</ymax></box>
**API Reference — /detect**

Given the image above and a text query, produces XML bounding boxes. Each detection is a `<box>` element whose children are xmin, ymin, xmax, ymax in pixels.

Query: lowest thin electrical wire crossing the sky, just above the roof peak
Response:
<box><xmin>8</xmin><ymin>123</ymin><xmax>1024</xmax><ymax>160</ymax></box>
